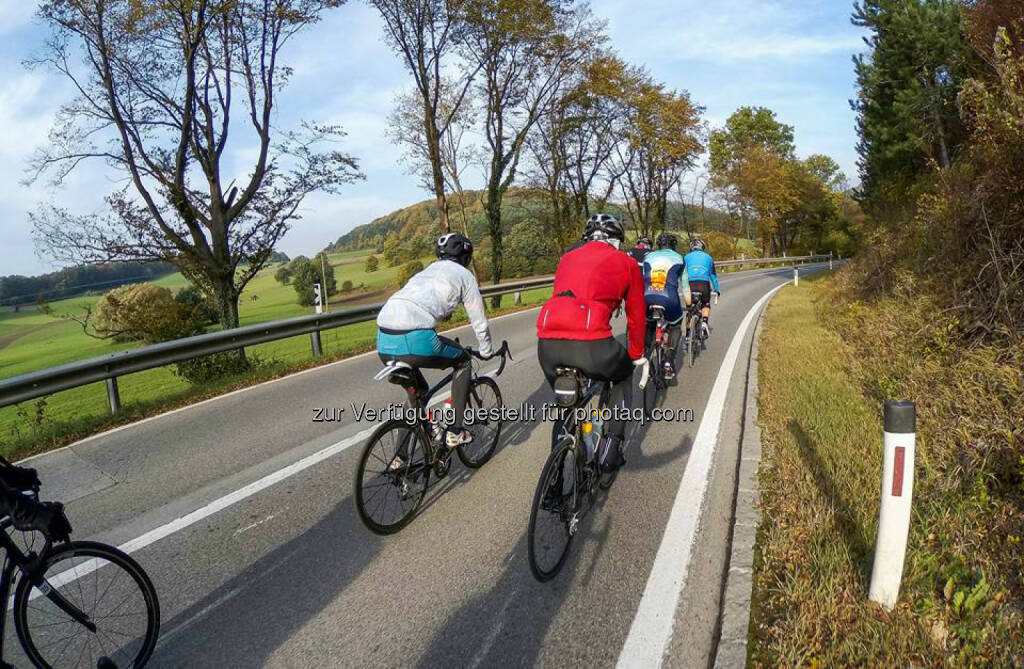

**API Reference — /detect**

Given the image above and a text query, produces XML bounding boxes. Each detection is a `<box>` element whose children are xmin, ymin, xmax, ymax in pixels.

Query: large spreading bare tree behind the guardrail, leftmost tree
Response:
<box><xmin>30</xmin><ymin>0</ymin><xmax>361</xmax><ymax>328</ymax></box>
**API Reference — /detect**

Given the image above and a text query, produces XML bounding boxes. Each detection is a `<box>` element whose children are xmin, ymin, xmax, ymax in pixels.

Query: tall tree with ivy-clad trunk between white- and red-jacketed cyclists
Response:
<box><xmin>463</xmin><ymin>0</ymin><xmax>599</xmax><ymax>304</ymax></box>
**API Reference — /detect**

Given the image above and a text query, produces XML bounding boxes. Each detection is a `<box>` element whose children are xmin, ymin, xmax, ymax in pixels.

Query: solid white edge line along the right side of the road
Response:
<box><xmin>616</xmin><ymin>282</ymin><xmax>788</xmax><ymax>669</ymax></box>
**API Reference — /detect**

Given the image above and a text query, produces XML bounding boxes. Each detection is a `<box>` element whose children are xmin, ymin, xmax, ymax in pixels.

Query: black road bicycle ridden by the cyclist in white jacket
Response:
<box><xmin>355</xmin><ymin>341</ymin><xmax>512</xmax><ymax>535</ymax></box>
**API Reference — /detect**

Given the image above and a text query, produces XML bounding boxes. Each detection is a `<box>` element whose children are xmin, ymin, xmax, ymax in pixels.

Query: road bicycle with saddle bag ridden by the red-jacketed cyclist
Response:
<box><xmin>527</xmin><ymin>367</ymin><xmax>649</xmax><ymax>582</ymax></box>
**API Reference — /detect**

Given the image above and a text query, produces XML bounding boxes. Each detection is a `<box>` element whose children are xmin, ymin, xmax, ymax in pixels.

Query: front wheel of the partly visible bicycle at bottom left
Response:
<box><xmin>14</xmin><ymin>541</ymin><xmax>160</xmax><ymax>669</ymax></box>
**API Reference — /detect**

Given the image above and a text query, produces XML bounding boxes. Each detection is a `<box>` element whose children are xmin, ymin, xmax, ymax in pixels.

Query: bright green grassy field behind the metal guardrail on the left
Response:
<box><xmin>0</xmin><ymin>251</ymin><xmax>550</xmax><ymax>455</ymax></box>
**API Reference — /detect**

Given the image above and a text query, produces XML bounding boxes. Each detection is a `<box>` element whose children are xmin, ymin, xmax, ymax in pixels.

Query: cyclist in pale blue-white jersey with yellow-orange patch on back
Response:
<box><xmin>643</xmin><ymin>233</ymin><xmax>689</xmax><ymax>379</ymax></box>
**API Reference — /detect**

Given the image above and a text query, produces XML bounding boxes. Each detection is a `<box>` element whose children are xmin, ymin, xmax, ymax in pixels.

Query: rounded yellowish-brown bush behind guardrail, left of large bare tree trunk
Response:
<box><xmin>90</xmin><ymin>284</ymin><xmax>208</xmax><ymax>343</ymax></box>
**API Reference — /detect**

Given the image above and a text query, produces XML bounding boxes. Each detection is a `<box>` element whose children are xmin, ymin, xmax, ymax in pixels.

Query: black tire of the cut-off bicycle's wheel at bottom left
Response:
<box><xmin>13</xmin><ymin>541</ymin><xmax>160</xmax><ymax>669</ymax></box>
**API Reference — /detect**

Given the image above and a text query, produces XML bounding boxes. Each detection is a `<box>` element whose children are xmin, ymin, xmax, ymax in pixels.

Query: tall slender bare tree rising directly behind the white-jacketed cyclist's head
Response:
<box><xmin>370</xmin><ymin>0</ymin><xmax>478</xmax><ymax>233</ymax></box>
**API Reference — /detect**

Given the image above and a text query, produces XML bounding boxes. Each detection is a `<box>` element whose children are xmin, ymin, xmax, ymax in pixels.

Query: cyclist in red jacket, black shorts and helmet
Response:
<box><xmin>537</xmin><ymin>214</ymin><xmax>647</xmax><ymax>470</ymax></box>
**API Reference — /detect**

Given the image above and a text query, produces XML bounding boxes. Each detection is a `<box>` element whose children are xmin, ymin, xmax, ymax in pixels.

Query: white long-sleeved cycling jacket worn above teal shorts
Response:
<box><xmin>377</xmin><ymin>260</ymin><xmax>493</xmax><ymax>356</ymax></box>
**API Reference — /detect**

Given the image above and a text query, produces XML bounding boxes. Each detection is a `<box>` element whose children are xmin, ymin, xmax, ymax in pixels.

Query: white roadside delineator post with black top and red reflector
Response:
<box><xmin>867</xmin><ymin>402</ymin><xmax>916</xmax><ymax>610</ymax></box>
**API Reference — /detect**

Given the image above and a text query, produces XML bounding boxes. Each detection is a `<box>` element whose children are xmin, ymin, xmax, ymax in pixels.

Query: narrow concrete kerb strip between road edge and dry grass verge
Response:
<box><xmin>714</xmin><ymin>288</ymin><xmax>771</xmax><ymax>669</ymax></box>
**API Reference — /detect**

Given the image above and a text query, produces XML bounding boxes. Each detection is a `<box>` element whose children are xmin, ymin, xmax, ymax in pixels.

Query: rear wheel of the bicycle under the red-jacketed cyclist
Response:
<box><xmin>527</xmin><ymin>436</ymin><xmax>580</xmax><ymax>582</ymax></box>
